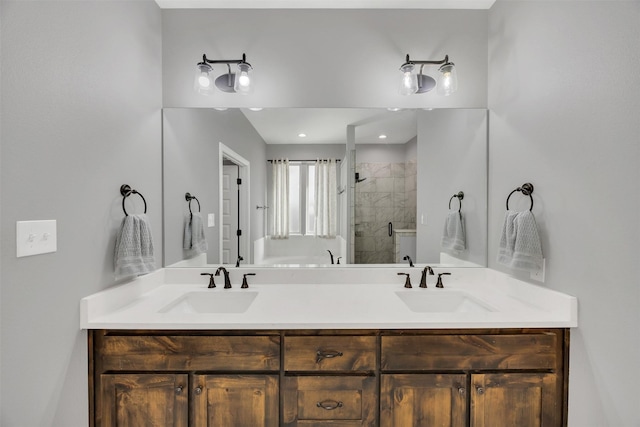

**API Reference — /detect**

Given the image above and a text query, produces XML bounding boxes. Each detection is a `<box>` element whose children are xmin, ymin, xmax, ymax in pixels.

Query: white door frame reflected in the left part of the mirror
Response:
<box><xmin>218</xmin><ymin>142</ymin><xmax>252</xmax><ymax>264</ymax></box>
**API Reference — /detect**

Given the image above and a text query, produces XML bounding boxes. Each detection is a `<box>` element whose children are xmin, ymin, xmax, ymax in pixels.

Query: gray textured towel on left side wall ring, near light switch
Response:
<box><xmin>113</xmin><ymin>214</ymin><xmax>156</xmax><ymax>277</ymax></box>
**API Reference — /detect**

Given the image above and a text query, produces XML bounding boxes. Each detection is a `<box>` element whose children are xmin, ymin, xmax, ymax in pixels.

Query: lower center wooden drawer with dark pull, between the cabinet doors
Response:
<box><xmin>283</xmin><ymin>376</ymin><xmax>377</xmax><ymax>427</ymax></box>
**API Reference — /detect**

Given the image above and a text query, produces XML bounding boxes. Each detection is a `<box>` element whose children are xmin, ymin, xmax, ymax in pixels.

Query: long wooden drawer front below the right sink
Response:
<box><xmin>381</xmin><ymin>332</ymin><xmax>562</xmax><ymax>371</ymax></box>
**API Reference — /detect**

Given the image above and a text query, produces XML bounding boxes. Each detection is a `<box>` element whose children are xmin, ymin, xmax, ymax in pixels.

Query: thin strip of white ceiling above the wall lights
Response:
<box><xmin>156</xmin><ymin>0</ymin><xmax>495</xmax><ymax>9</ymax></box>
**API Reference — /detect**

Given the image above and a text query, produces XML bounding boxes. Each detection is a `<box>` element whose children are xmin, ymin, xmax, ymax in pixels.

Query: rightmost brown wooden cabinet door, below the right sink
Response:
<box><xmin>471</xmin><ymin>373</ymin><xmax>562</xmax><ymax>427</ymax></box>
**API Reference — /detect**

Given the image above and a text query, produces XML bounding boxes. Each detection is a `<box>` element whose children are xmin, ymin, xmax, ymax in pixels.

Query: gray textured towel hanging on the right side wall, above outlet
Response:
<box><xmin>497</xmin><ymin>211</ymin><xmax>542</xmax><ymax>271</ymax></box>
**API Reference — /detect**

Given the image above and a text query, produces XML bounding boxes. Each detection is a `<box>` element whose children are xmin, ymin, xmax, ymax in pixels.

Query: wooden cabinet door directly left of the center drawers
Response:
<box><xmin>193</xmin><ymin>375</ymin><xmax>279</xmax><ymax>427</ymax></box>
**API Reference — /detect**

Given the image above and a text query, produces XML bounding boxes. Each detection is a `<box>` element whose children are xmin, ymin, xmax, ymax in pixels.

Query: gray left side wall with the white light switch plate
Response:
<box><xmin>0</xmin><ymin>1</ymin><xmax>162</xmax><ymax>427</ymax></box>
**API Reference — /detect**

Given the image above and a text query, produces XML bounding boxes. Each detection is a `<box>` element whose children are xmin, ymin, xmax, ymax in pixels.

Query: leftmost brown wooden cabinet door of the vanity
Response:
<box><xmin>96</xmin><ymin>374</ymin><xmax>188</xmax><ymax>427</ymax></box>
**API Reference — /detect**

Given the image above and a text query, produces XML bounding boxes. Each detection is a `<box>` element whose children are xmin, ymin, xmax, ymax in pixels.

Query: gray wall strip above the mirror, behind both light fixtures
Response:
<box><xmin>162</xmin><ymin>9</ymin><xmax>488</xmax><ymax>108</ymax></box>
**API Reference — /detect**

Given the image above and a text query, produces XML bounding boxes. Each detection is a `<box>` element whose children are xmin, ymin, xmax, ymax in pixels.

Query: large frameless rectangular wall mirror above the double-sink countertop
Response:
<box><xmin>163</xmin><ymin>108</ymin><xmax>488</xmax><ymax>267</ymax></box>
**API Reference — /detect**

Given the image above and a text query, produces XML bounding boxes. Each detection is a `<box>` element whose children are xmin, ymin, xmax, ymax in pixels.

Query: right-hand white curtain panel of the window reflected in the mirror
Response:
<box><xmin>315</xmin><ymin>159</ymin><xmax>338</xmax><ymax>239</ymax></box>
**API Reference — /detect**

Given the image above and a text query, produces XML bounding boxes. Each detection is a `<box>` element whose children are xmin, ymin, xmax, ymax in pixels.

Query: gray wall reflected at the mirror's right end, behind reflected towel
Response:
<box><xmin>416</xmin><ymin>109</ymin><xmax>487</xmax><ymax>265</ymax></box>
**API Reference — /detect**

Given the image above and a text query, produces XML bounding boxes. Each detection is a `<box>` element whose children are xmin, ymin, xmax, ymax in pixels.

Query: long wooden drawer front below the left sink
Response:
<box><xmin>96</xmin><ymin>335</ymin><xmax>280</xmax><ymax>371</ymax></box>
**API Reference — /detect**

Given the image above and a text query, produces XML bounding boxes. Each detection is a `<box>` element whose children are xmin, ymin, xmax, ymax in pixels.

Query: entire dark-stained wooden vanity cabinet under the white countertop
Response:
<box><xmin>89</xmin><ymin>328</ymin><xmax>569</xmax><ymax>427</ymax></box>
